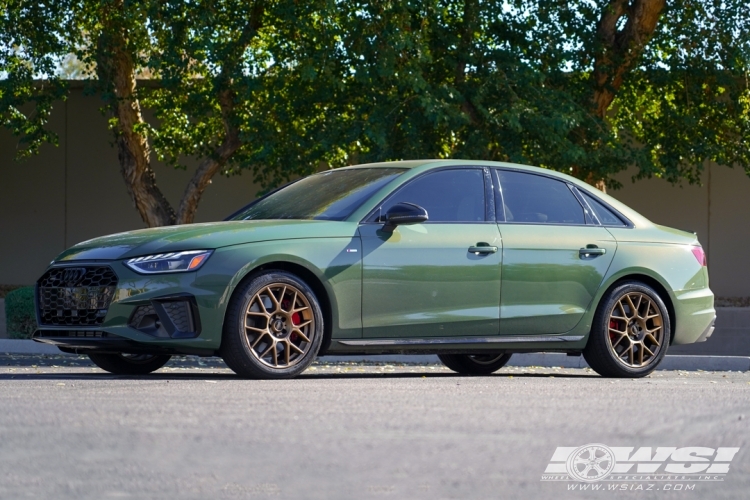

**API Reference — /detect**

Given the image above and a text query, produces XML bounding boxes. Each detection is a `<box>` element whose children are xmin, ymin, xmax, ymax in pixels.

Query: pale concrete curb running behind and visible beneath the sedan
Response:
<box><xmin>0</xmin><ymin>339</ymin><xmax>750</xmax><ymax>371</ymax></box>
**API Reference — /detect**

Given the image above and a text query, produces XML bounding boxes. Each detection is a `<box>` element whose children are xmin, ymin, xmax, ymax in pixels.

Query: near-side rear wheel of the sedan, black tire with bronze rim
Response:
<box><xmin>583</xmin><ymin>281</ymin><xmax>672</xmax><ymax>378</ymax></box>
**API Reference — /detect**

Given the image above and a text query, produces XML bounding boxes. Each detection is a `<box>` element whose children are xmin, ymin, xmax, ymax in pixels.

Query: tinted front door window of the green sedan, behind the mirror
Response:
<box><xmin>381</xmin><ymin>169</ymin><xmax>484</xmax><ymax>222</ymax></box>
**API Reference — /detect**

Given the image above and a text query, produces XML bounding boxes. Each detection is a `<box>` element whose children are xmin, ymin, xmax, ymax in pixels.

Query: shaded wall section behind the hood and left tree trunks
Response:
<box><xmin>0</xmin><ymin>90</ymin><xmax>259</xmax><ymax>284</ymax></box>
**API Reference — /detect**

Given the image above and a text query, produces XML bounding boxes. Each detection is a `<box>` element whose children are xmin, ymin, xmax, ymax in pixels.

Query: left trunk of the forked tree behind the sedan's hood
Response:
<box><xmin>97</xmin><ymin>1</ymin><xmax>176</xmax><ymax>227</ymax></box>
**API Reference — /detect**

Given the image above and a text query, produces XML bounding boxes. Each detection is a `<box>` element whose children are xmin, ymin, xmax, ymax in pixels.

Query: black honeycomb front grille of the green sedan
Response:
<box><xmin>38</xmin><ymin>266</ymin><xmax>117</xmax><ymax>326</ymax></box>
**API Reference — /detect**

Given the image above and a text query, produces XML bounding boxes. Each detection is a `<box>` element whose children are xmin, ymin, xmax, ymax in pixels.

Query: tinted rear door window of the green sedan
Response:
<box><xmin>497</xmin><ymin>170</ymin><xmax>586</xmax><ymax>224</ymax></box>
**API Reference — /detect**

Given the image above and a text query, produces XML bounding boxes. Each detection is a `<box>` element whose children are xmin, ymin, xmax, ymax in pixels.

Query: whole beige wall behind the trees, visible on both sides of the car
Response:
<box><xmin>0</xmin><ymin>90</ymin><xmax>750</xmax><ymax>297</ymax></box>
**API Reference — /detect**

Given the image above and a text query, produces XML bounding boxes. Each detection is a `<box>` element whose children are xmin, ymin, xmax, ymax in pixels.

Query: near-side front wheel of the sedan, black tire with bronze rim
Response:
<box><xmin>221</xmin><ymin>271</ymin><xmax>324</xmax><ymax>379</ymax></box>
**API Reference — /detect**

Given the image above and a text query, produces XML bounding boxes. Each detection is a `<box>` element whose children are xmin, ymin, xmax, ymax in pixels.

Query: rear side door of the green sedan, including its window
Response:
<box><xmin>498</xmin><ymin>170</ymin><xmax>617</xmax><ymax>335</ymax></box>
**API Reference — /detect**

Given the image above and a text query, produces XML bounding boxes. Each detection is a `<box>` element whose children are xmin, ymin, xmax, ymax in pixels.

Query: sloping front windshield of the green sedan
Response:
<box><xmin>229</xmin><ymin>168</ymin><xmax>404</xmax><ymax>220</ymax></box>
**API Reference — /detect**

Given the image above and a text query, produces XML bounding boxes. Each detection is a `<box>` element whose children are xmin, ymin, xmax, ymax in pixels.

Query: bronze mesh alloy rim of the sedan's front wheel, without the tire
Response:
<box><xmin>245</xmin><ymin>283</ymin><xmax>315</xmax><ymax>368</ymax></box>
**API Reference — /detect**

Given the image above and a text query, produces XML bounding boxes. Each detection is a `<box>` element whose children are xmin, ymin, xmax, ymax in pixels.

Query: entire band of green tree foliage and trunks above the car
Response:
<box><xmin>0</xmin><ymin>0</ymin><xmax>750</xmax><ymax>225</ymax></box>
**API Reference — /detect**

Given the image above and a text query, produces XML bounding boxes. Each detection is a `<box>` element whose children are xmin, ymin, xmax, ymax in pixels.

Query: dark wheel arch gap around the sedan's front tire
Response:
<box><xmin>222</xmin><ymin>260</ymin><xmax>333</xmax><ymax>356</ymax></box>
